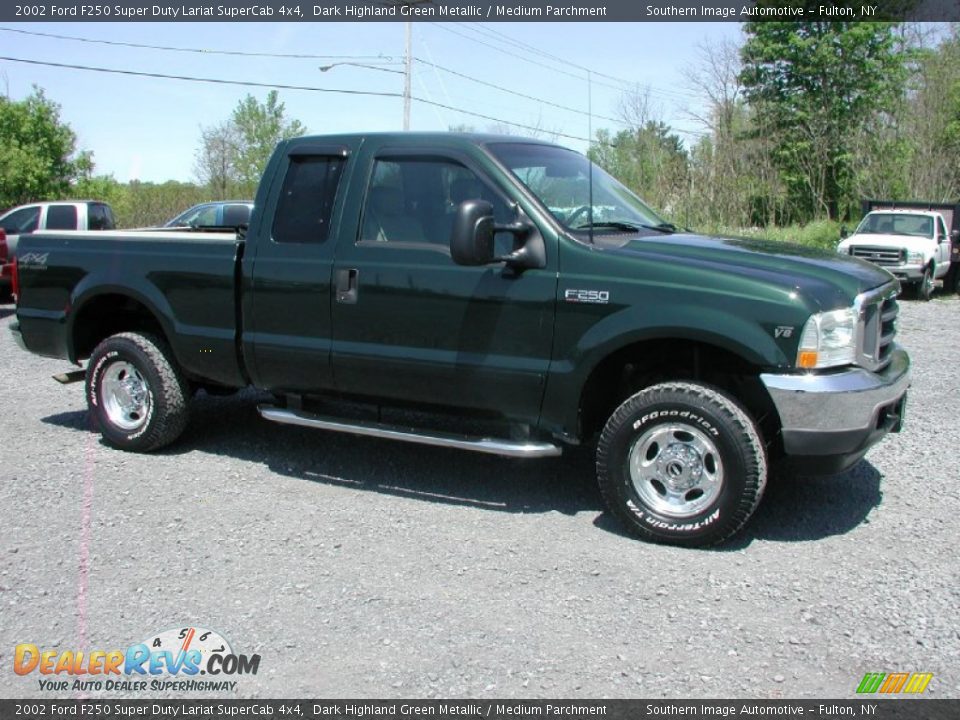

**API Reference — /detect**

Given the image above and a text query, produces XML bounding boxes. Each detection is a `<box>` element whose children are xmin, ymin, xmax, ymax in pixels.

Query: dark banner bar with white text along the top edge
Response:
<box><xmin>0</xmin><ymin>0</ymin><xmax>960</xmax><ymax>22</ymax></box>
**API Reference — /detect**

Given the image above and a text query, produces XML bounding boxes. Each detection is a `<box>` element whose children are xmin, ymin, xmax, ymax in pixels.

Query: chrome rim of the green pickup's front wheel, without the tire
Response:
<box><xmin>629</xmin><ymin>424</ymin><xmax>723</xmax><ymax>518</ymax></box>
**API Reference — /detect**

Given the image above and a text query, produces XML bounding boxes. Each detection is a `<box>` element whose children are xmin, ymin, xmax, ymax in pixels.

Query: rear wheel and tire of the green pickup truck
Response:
<box><xmin>86</xmin><ymin>332</ymin><xmax>190</xmax><ymax>452</ymax></box>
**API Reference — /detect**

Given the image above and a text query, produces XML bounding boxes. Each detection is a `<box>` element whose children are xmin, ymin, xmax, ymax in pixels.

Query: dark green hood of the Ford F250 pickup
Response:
<box><xmin>597</xmin><ymin>234</ymin><xmax>893</xmax><ymax>310</ymax></box>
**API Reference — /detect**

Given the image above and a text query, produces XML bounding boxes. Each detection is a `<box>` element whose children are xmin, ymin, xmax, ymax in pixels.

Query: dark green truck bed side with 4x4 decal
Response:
<box><xmin>18</xmin><ymin>231</ymin><xmax>245</xmax><ymax>386</ymax></box>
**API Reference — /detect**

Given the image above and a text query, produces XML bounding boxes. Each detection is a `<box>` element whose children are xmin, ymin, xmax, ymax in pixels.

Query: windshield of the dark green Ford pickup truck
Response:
<box><xmin>489</xmin><ymin>143</ymin><xmax>672</xmax><ymax>232</ymax></box>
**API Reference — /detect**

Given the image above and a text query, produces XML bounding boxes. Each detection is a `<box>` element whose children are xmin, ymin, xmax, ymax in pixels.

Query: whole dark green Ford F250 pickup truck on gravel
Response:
<box><xmin>12</xmin><ymin>133</ymin><xmax>909</xmax><ymax>546</ymax></box>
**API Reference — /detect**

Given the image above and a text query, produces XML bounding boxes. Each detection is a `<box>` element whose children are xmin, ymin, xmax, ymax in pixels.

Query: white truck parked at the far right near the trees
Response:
<box><xmin>837</xmin><ymin>207</ymin><xmax>958</xmax><ymax>300</ymax></box>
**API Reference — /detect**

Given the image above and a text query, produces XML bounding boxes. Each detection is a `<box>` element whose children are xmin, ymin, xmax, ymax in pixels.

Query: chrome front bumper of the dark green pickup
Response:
<box><xmin>760</xmin><ymin>347</ymin><xmax>910</xmax><ymax>455</ymax></box>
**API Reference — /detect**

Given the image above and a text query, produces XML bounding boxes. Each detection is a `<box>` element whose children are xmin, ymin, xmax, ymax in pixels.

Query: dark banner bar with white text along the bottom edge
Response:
<box><xmin>0</xmin><ymin>695</ymin><xmax>960</xmax><ymax>720</ymax></box>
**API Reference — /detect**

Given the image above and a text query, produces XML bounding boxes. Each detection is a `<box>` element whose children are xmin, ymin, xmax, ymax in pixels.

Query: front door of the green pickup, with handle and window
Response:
<box><xmin>333</xmin><ymin>148</ymin><xmax>557</xmax><ymax>423</ymax></box>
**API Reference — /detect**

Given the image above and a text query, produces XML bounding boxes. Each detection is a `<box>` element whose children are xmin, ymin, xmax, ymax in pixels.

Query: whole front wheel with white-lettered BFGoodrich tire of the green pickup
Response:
<box><xmin>597</xmin><ymin>382</ymin><xmax>767</xmax><ymax>547</ymax></box>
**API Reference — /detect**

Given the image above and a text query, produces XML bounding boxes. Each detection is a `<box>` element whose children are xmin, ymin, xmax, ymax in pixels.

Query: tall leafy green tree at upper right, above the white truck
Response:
<box><xmin>740</xmin><ymin>21</ymin><xmax>907</xmax><ymax>221</ymax></box>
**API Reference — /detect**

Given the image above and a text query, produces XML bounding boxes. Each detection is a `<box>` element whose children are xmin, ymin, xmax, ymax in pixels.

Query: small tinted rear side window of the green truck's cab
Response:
<box><xmin>273</xmin><ymin>155</ymin><xmax>345</xmax><ymax>244</ymax></box>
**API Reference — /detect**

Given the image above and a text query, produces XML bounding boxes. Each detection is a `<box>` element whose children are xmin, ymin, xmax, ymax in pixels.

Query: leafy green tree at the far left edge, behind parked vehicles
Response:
<box><xmin>0</xmin><ymin>86</ymin><xmax>93</xmax><ymax>207</ymax></box>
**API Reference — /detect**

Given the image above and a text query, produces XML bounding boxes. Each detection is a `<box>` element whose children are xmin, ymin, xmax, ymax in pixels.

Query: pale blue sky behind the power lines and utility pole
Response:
<box><xmin>0</xmin><ymin>22</ymin><xmax>740</xmax><ymax>182</ymax></box>
